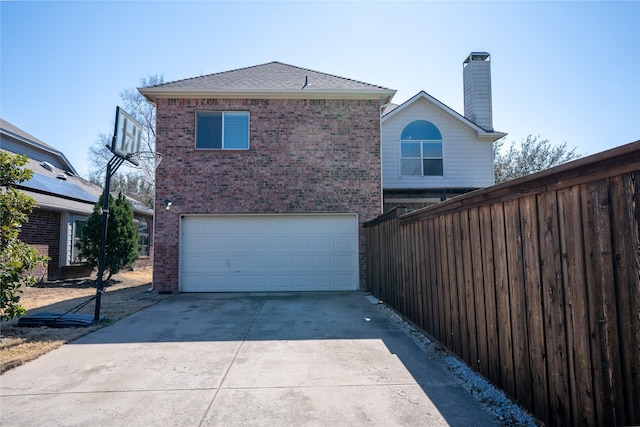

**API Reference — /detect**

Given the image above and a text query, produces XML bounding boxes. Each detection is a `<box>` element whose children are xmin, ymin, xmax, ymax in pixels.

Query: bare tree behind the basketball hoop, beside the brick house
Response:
<box><xmin>89</xmin><ymin>75</ymin><xmax>164</xmax><ymax>207</ymax></box>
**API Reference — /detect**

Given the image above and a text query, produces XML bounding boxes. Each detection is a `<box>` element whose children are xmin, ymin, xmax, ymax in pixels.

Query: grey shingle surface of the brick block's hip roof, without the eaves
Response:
<box><xmin>147</xmin><ymin>61</ymin><xmax>389</xmax><ymax>91</ymax></box>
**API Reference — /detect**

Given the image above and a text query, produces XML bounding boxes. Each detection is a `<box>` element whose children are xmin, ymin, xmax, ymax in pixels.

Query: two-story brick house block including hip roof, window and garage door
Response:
<box><xmin>139</xmin><ymin>62</ymin><xmax>395</xmax><ymax>292</ymax></box>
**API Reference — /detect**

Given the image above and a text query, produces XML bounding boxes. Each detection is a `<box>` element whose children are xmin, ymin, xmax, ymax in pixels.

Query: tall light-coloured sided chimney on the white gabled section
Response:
<box><xmin>462</xmin><ymin>52</ymin><xmax>493</xmax><ymax>131</ymax></box>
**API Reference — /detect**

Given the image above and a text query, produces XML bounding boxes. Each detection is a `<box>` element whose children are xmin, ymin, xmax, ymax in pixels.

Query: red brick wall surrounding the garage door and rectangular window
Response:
<box><xmin>153</xmin><ymin>99</ymin><xmax>381</xmax><ymax>291</ymax></box>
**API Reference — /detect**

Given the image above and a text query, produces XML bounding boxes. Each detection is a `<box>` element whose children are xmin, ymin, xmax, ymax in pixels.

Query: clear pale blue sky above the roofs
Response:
<box><xmin>0</xmin><ymin>1</ymin><xmax>640</xmax><ymax>175</ymax></box>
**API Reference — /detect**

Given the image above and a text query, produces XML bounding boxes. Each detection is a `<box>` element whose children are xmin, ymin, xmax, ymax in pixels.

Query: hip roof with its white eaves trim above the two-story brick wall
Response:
<box><xmin>138</xmin><ymin>61</ymin><xmax>395</xmax><ymax>104</ymax></box>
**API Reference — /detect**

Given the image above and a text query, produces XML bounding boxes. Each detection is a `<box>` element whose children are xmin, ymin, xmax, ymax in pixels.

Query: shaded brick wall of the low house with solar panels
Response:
<box><xmin>20</xmin><ymin>209</ymin><xmax>60</xmax><ymax>280</ymax></box>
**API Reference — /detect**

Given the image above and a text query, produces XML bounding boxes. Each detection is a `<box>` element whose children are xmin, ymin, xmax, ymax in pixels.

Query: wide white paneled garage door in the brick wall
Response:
<box><xmin>180</xmin><ymin>214</ymin><xmax>358</xmax><ymax>292</ymax></box>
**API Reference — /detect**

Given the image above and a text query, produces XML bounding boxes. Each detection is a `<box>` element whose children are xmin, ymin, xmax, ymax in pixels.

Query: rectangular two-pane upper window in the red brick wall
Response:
<box><xmin>196</xmin><ymin>111</ymin><xmax>249</xmax><ymax>150</ymax></box>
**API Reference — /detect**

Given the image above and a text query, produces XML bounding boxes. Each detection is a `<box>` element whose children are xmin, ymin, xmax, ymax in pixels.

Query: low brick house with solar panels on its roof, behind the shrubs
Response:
<box><xmin>0</xmin><ymin>119</ymin><xmax>153</xmax><ymax>281</ymax></box>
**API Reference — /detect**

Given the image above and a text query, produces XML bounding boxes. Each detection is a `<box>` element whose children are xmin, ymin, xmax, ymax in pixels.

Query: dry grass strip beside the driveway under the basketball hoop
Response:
<box><xmin>0</xmin><ymin>270</ymin><xmax>172</xmax><ymax>373</ymax></box>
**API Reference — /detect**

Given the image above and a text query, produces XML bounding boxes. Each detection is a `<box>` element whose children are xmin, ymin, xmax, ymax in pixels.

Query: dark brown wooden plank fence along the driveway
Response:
<box><xmin>364</xmin><ymin>141</ymin><xmax>640</xmax><ymax>426</ymax></box>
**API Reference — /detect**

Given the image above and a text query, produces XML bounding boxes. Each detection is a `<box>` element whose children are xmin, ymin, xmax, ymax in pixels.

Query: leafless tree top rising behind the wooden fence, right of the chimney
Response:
<box><xmin>493</xmin><ymin>135</ymin><xmax>581</xmax><ymax>184</ymax></box>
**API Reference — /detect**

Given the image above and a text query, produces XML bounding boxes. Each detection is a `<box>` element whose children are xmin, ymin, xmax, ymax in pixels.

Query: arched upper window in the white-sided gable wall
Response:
<box><xmin>400</xmin><ymin>120</ymin><xmax>444</xmax><ymax>176</ymax></box>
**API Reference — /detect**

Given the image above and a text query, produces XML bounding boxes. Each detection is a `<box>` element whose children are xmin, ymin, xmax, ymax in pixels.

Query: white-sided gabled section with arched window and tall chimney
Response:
<box><xmin>381</xmin><ymin>52</ymin><xmax>506</xmax><ymax>211</ymax></box>
